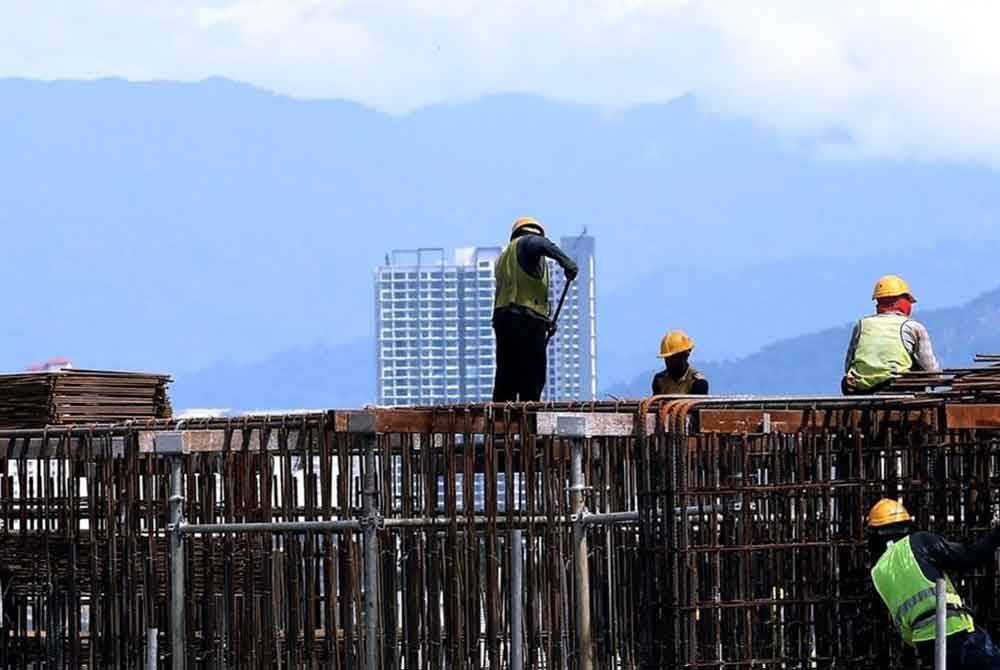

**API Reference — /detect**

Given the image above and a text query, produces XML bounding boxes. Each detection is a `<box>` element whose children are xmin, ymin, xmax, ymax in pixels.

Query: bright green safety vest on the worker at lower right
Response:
<box><xmin>872</xmin><ymin>536</ymin><xmax>975</xmax><ymax>645</ymax></box>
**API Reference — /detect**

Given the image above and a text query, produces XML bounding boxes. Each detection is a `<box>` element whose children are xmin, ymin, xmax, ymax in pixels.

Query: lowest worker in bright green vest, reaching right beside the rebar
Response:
<box><xmin>868</xmin><ymin>498</ymin><xmax>1000</xmax><ymax>669</ymax></box>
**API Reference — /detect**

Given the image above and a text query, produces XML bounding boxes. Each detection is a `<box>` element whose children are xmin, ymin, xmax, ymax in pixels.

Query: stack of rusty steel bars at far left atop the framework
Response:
<box><xmin>0</xmin><ymin>369</ymin><xmax>172</xmax><ymax>428</ymax></box>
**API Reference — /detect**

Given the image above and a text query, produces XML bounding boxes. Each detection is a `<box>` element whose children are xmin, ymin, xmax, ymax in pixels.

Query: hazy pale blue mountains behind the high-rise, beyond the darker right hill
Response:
<box><xmin>0</xmin><ymin>79</ymin><xmax>1000</xmax><ymax>407</ymax></box>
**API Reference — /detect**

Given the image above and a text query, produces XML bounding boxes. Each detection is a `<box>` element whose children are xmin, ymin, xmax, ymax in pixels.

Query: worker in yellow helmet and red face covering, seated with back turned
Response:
<box><xmin>841</xmin><ymin>275</ymin><xmax>941</xmax><ymax>395</ymax></box>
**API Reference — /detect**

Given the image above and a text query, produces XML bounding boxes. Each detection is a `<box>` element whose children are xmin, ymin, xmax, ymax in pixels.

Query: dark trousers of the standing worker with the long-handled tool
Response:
<box><xmin>493</xmin><ymin>309</ymin><xmax>548</xmax><ymax>402</ymax></box>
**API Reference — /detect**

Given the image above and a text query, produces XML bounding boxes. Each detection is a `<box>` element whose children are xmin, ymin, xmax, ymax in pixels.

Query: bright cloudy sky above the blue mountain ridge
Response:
<box><xmin>0</xmin><ymin>0</ymin><xmax>1000</xmax><ymax>166</ymax></box>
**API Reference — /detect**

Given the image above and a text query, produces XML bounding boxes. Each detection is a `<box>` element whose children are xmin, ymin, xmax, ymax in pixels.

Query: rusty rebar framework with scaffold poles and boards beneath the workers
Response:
<box><xmin>0</xmin><ymin>391</ymin><xmax>1000</xmax><ymax>669</ymax></box>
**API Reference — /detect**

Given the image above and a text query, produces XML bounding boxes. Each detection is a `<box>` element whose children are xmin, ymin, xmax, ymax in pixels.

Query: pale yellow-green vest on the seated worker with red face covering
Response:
<box><xmin>847</xmin><ymin>314</ymin><xmax>913</xmax><ymax>391</ymax></box>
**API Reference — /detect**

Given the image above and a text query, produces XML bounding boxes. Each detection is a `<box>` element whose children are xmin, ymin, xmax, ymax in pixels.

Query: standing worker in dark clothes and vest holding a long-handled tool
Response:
<box><xmin>493</xmin><ymin>217</ymin><xmax>579</xmax><ymax>402</ymax></box>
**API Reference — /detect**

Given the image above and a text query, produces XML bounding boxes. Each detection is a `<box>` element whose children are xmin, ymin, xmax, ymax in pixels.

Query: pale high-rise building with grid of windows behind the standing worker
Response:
<box><xmin>375</xmin><ymin>234</ymin><xmax>597</xmax><ymax>405</ymax></box>
